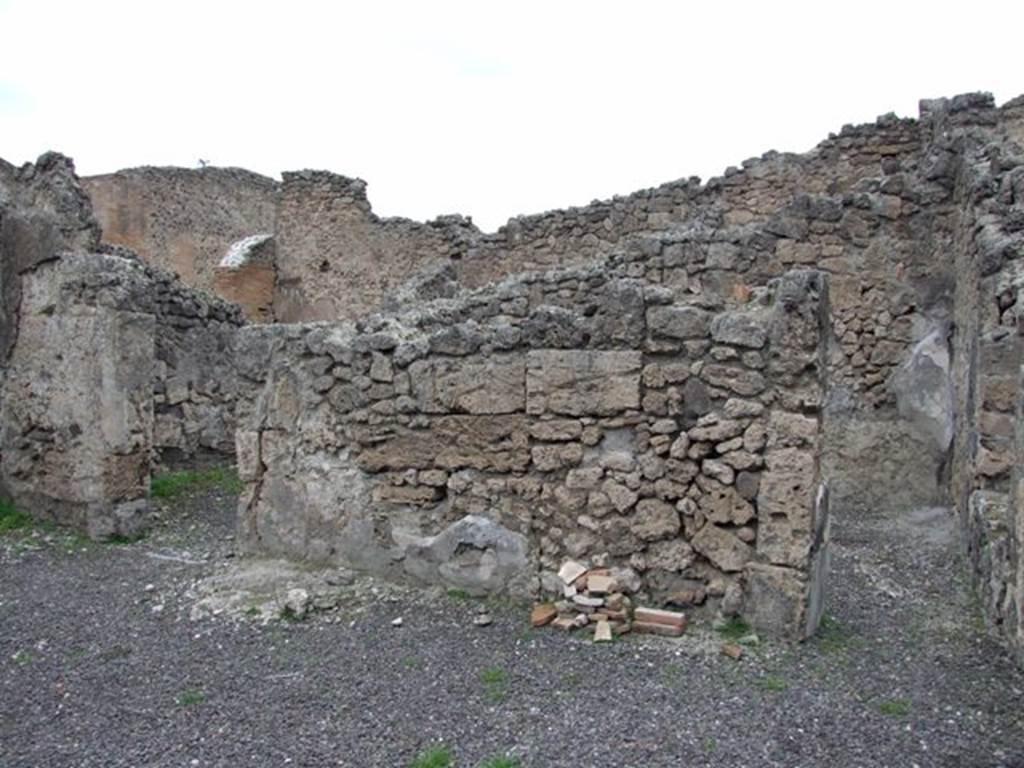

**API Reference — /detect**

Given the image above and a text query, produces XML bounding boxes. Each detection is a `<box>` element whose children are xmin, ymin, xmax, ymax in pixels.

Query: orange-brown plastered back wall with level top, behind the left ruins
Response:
<box><xmin>82</xmin><ymin>167</ymin><xmax>279</xmax><ymax>303</ymax></box>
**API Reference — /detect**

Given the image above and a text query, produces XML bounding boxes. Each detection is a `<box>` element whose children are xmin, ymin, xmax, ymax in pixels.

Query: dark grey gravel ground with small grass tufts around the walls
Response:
<box><xmin>0</xmin><ymin>475</ymin><xmax>1024</xmax><ymax>768</ymax></box>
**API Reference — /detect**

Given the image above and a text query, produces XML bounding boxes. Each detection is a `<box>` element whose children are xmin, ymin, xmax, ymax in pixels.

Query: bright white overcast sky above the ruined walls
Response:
<box><xmin>0</xmin><ymin>0</ymin><xmax>1024</xmax><ymax>230</ymax></box>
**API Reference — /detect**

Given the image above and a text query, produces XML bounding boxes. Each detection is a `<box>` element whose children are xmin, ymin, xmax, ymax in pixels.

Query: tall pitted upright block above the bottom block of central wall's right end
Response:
<box><xmin>758</xmin><ymin>449</ymin><xmax>817</xmax><ymax>567</ymax></box>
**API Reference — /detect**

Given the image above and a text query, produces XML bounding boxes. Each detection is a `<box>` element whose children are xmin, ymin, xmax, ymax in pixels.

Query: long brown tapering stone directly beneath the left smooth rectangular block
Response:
<box><xmin>358</xmin><ymin>415</ymin><xmax>530</xmax><ymax>472</ymax></box>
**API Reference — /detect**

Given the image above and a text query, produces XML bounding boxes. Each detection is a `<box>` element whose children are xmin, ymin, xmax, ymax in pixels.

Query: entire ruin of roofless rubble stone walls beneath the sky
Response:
<box><xmin>0</xmin><ymin>94</ymin><xmax>1024</xmax><ymax>658</ymax></box>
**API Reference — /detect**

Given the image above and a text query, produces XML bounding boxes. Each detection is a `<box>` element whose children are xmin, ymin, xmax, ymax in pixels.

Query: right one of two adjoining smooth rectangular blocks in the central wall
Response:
<box><xmin>526</xmin><ymin>349</ymin><xmax>641</xmax><ymax>416</ymax></box>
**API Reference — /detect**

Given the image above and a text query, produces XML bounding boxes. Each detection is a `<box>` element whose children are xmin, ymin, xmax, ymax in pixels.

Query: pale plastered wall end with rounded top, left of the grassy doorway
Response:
<box><xmin>0</xmin><ymin>249</ymin><xmax>156</xmax><ymax>538</ymax></box>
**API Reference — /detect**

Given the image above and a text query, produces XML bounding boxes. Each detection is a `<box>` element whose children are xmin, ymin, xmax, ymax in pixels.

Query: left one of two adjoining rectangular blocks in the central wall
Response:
<box><xmin>409</xmin><ymin>354</ymin><xmax>526</xmax><ymax>414</ymax></box>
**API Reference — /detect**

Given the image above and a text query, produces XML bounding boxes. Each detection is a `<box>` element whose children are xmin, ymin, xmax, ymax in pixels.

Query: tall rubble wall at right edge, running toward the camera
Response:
<box><xmin>936</xmin><ymin>94</ymin><xmax>1024</xmax><ymax>658</ymax></box>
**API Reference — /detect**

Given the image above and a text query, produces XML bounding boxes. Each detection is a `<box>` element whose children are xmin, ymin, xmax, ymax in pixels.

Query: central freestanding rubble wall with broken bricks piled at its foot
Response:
<box><xmin>237</xmin><ymin>237</ymin><xmax>826</xmax><ymax>637</ymax></box>
